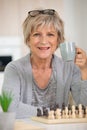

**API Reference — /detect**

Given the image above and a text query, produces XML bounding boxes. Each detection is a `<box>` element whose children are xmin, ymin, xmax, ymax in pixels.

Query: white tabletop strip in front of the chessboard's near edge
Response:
<box><xmin>17</xmin><ymin>119</ymin><xmax>87</xmax><ymax>130</ymax></box>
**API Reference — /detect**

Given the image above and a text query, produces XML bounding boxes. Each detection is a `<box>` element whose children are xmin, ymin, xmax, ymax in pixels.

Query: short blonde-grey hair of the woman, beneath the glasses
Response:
<box><xmin>23</xmin><ymin>8</ymin><xmax>64</xmax><ymax>44</ymax></box>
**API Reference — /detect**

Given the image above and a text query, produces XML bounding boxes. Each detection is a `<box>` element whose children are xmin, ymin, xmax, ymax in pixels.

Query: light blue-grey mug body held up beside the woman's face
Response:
<box><xmin>60</xmin><ymin>42</ymin><xmax>76</xmax><ymax>61</ymax></box>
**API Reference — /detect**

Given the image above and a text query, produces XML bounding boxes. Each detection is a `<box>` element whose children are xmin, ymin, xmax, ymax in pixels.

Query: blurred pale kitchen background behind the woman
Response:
<box><xmin>0</xmin><ymin>0</ymin><xmax>87</xmax><ymax>92</ymax></box>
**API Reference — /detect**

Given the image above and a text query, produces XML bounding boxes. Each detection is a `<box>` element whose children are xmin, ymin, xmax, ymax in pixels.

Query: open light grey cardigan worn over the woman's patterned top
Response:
<box><xmin>3</xmin><ymin>54</ymin><xmax>87</xmax><ymax>118</ymax></box>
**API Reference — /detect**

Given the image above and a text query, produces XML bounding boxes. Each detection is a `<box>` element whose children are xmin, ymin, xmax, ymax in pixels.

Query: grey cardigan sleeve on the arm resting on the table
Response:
<box><xmin>2</xmin><ymin>62</ymin><xmax>37</xmax><ymax>118</ymax></box>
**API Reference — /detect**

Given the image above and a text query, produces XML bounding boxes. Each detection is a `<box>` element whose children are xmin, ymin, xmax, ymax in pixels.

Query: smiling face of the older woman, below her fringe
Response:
<box><xmin>28</xmin><ymin>25</ymin><xmax>58</xmax><ymax>59</ymax></box>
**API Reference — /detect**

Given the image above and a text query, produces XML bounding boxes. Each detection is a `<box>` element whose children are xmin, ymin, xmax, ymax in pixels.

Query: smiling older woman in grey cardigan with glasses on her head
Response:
<box><xmin>3</xmin><ymin>9</ymin><xmax>87</xmax><ymax>118</ymax></box>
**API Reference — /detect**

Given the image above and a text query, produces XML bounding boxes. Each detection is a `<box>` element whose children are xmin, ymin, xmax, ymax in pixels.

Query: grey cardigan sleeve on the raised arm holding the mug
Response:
<box><xmin>71</xmin><ymin>66</ymin><xmax>87</xmax><ymax>106</ymax></box>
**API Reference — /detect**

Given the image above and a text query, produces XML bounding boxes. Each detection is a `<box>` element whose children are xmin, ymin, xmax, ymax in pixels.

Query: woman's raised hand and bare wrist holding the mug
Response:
<box><xmin>75</xmin><ymin>48</ymin><xmax>87</xmax><ymax>80</ymax></box>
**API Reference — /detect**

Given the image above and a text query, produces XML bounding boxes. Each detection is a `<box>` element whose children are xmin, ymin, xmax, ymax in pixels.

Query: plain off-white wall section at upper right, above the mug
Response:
<box><xmin>63</xmin><ymin>0</ymin><xmax>87</xmax><ymax>52</ymax></box>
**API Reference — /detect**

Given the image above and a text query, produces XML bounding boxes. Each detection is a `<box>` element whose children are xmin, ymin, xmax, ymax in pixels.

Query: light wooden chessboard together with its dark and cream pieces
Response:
<box><xmin>32</xmin><ymin>104</ymin><xmax>87</xmax><ymax>124</ymax></box>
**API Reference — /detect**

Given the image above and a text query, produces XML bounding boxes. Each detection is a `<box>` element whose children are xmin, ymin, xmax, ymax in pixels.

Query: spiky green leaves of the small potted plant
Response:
<box><xmin>0</xmin><ymin>91</ymin><xmax>13</xmax><ymax>112</ymax></box>
